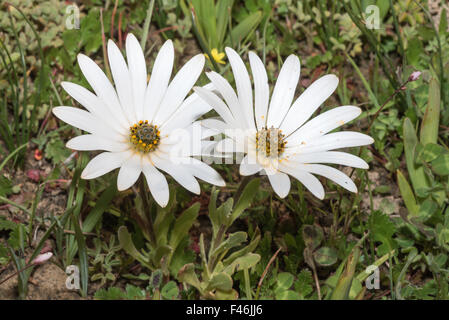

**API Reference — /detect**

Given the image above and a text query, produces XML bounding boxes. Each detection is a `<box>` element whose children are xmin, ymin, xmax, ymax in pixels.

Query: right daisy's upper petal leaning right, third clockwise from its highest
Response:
<box><xmin>267</xmin><ymin>54</ymin><xmax>301</xmax><ymax>128</ymax></box>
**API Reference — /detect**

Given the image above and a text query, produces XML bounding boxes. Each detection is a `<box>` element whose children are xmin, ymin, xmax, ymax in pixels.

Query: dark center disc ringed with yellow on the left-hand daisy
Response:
<box><xmin>129</xmin><ymin>120</ymin><xmax>161</xmax><ymax>153</ymax></box>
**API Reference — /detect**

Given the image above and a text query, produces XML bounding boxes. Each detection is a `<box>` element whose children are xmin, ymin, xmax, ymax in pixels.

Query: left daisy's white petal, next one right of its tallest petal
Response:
<box><xmin>143</xmin><ymin>40</ymin><xmax>175</xmax><ymax>122</ymax></box>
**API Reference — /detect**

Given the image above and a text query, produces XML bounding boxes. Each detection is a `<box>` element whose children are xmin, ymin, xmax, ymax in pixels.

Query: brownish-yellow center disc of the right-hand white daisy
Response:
<box><xmin>256</xmin><ymin>127</ymin><xmax>287</xmax><ymax>158</ymax></box>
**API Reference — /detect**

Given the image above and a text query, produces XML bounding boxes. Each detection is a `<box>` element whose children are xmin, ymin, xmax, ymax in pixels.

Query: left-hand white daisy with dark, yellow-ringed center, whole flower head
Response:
<box><xmin>53</xmin><ymin>34</ymin><xmax>225</xmax><ymax>207</ymax></box>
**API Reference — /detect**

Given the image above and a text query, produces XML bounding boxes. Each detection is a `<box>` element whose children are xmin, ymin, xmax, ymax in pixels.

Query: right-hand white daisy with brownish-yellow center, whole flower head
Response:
<box><xmin>194</xmin><ymin>48</ymin><xmax>374</xmax><ymax>199</ymax></box>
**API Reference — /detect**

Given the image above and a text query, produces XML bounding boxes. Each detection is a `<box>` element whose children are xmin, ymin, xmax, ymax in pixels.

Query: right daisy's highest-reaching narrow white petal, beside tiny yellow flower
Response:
<box><xmin>225</xmin><ymin>48</ymin><xmax>256</xmax><ymax>129</ymax></box>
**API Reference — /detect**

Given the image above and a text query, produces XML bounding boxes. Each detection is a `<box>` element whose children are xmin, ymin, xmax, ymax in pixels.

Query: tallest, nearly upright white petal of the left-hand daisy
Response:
<box><xmin>126</xmin><ymin>33</ymin><xmax>147</xmax><ymax>120</ymax></box>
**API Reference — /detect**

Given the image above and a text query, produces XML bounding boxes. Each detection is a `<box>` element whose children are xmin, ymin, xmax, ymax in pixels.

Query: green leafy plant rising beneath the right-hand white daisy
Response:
<box><xmin>177</xmin><ymin>179</ymin><xmax>260</xmax><ymax>299</ymax></box>
